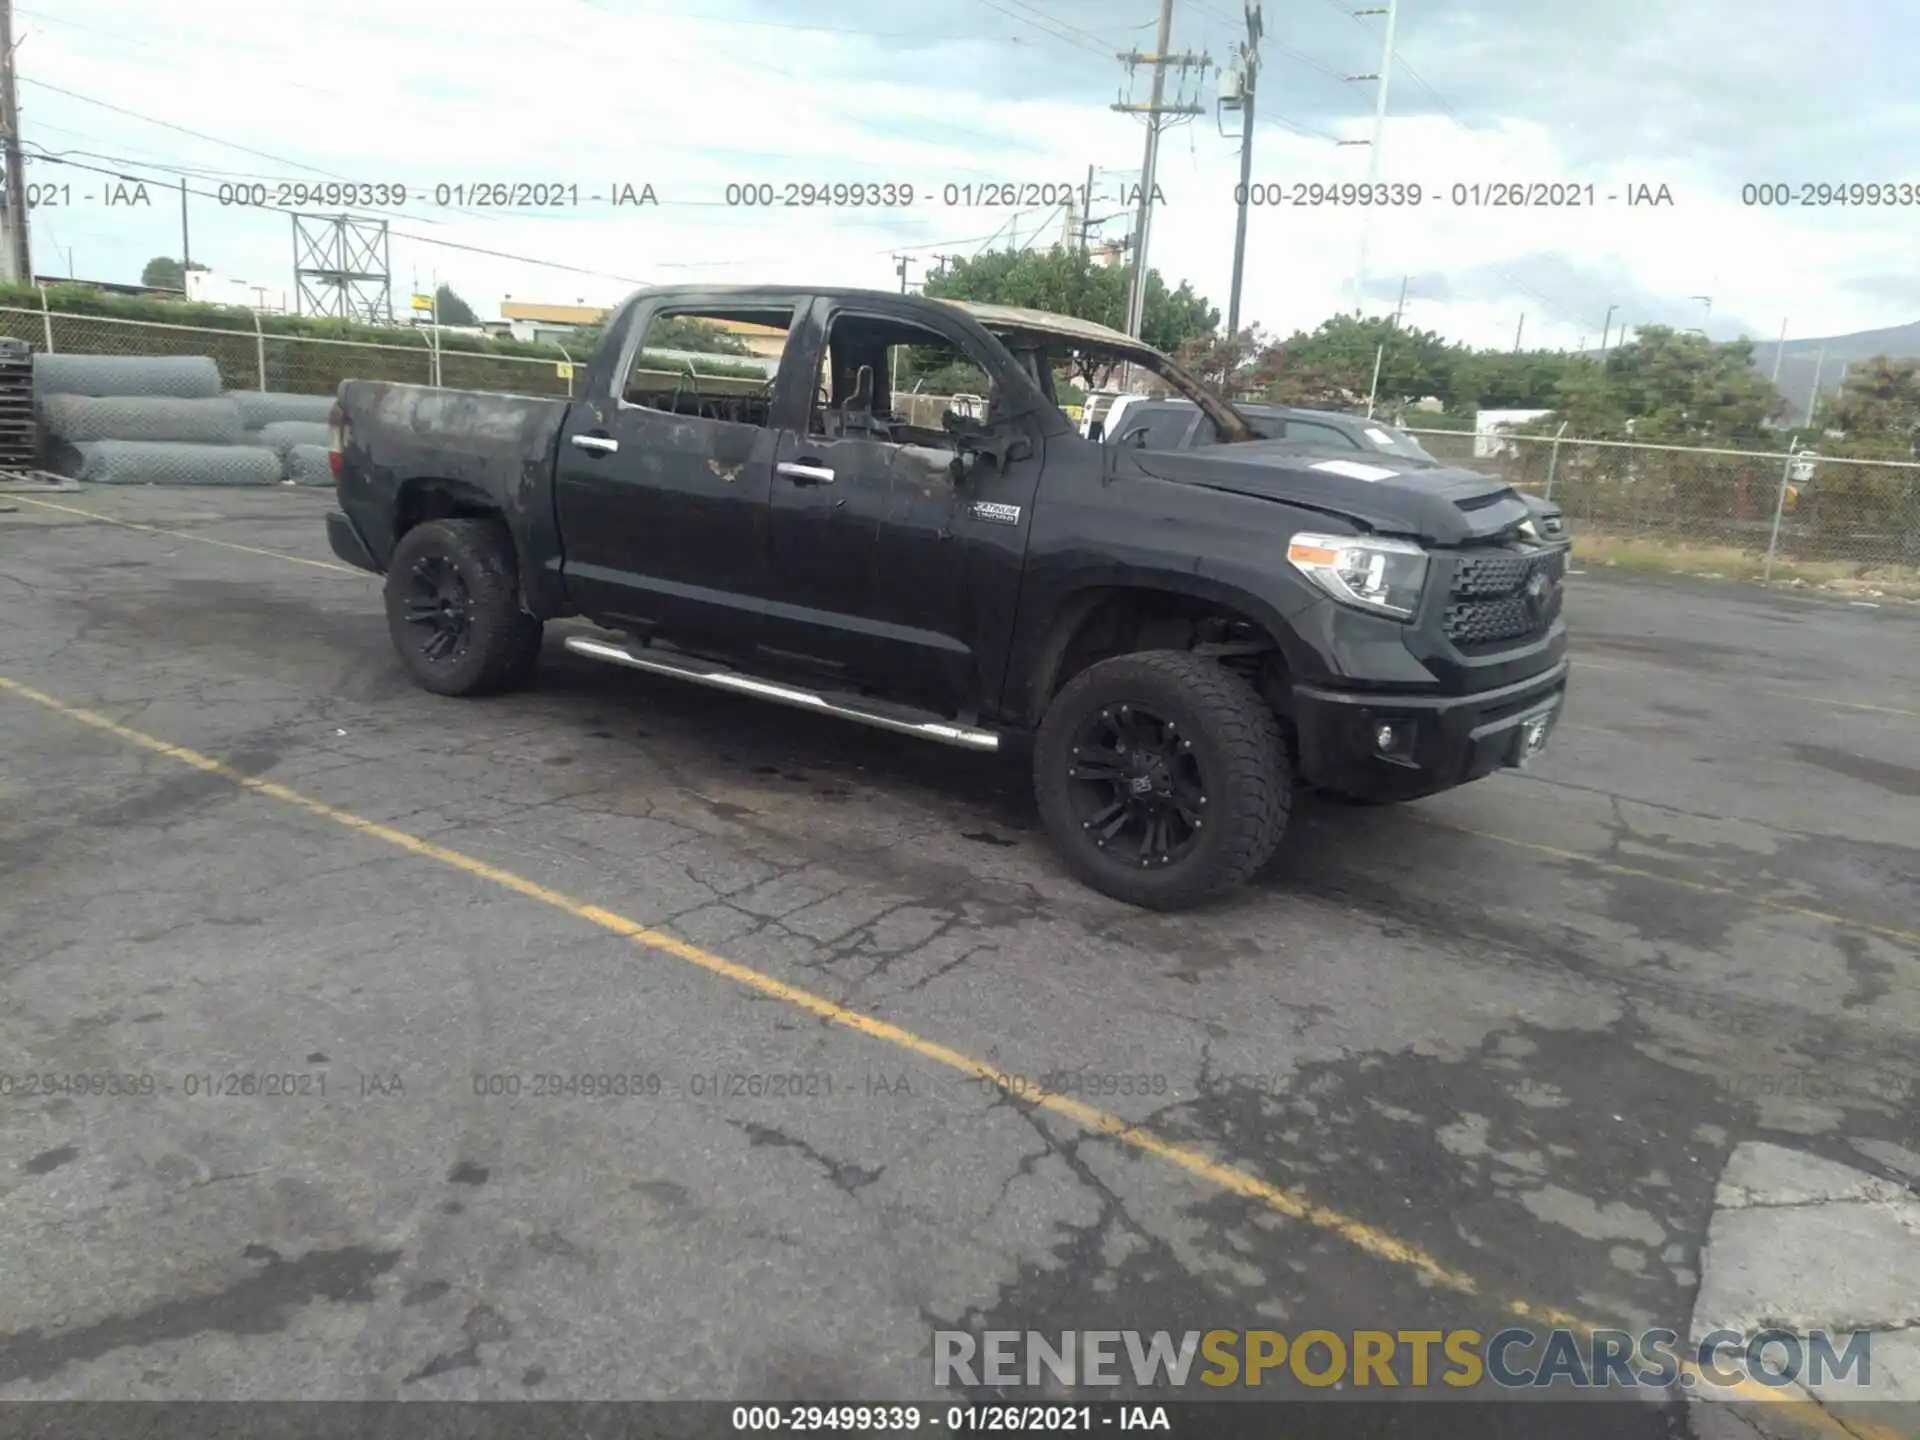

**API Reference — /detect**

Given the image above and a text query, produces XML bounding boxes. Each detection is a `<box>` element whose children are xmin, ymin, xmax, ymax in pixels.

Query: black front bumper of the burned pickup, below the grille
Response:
<box><xmin>1294</xmin><ymin>660</ymin><xmax>1569</xmax><ymax>801</ymax></box>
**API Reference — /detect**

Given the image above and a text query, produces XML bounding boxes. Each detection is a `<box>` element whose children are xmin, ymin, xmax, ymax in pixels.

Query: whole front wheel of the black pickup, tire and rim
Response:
<box><xmin>1033</xmin><ymin>651</ymin><xmax>1292</xmax><ymax>910</ymax></box>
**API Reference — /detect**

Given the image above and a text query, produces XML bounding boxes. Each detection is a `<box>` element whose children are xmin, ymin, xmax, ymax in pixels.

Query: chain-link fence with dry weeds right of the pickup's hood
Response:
<box><xmin>1409</xmin><ymin>430</ymin><xmax>1920</xmax><ymax>566</ymax></box>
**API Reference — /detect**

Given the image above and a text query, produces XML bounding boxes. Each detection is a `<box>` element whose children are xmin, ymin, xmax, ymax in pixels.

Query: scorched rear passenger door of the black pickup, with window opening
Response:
<box><xmin>555</xmin><ymin>298</ymin><xmax>804</xmax><ymax>649</ymax></box>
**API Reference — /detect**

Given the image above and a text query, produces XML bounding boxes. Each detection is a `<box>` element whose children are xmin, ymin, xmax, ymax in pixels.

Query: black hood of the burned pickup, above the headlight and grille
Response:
<box><xmin>1114</xmin><ymin>442</ymin><xmax>1530</xmax><ymax>545</ymax></box>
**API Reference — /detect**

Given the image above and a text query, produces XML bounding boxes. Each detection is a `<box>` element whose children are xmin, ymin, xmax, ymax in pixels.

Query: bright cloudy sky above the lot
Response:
<box><xmin>15</xmin><ymin>0</ymin><xmax>1920</xmax><ymax>359</ymax></box>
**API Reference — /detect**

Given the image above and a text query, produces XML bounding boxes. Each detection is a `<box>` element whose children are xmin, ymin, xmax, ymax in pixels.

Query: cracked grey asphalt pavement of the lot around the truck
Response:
<box><xmin>0</xmin><ymin>492</ymin><xmax>1920</xmax><ymax>1428</ymax></box>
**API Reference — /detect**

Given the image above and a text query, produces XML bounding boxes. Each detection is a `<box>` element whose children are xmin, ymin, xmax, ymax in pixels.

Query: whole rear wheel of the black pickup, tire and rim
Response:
<box><xmin>386</xmin><ymin>520</ymin><xmax>541</xmax><ymax>695</ymax></box>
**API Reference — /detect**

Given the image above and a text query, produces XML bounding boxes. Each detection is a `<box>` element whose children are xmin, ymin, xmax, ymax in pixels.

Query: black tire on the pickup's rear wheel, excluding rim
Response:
<box><xmin>386</xmin><ymin>520</ymin><xmax>543</xmax><ymax>695</ymax></box>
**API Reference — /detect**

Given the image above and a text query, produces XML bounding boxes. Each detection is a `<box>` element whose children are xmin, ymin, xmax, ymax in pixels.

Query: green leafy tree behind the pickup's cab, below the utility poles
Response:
<box><xmin>924</xmin><ymin>246</ymin><xmax>1219</xmax><ymax>366</ymax></box>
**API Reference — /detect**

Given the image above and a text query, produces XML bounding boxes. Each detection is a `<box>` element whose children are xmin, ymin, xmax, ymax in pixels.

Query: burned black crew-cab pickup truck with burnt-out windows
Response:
<box><xmin>326</xmin><ymin>286</ymin><xmax>1569</xmax><ymax>910</ymax></box>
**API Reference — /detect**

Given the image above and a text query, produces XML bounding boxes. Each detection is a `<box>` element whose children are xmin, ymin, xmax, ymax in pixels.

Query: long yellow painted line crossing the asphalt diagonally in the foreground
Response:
<box><xmin>0</xmin><ymin>676</ymin><xmax>1897</xmax><ymax>1440</ymax></box>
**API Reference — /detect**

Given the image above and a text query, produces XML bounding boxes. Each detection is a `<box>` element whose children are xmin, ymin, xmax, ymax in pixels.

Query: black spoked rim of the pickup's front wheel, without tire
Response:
<box><xmin>1068</xmin><ymin>705</ymin><xmax>1208</xmax><ymax>870</ymax></box>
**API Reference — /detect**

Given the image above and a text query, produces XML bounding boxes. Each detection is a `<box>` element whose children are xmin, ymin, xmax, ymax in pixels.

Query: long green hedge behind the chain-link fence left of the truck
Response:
<box><xmin>0</xmin><ymin>307</ymin><xmax>586</xmax><ymax>397</ymax></box>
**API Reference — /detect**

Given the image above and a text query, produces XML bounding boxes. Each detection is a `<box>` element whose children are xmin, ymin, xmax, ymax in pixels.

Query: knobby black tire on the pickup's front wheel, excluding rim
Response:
<box><xmin>1033</xmin><ymin>651</ymin><xmax>1294</xmax><ymax>910</ymax></box>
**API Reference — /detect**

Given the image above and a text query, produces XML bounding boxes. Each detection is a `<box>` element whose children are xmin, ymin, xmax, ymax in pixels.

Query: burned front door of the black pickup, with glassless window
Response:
<box><xmin>762</xmin><ymin>300</ymin><xmax>1041</xmax><ymax>714</ymax></box>
